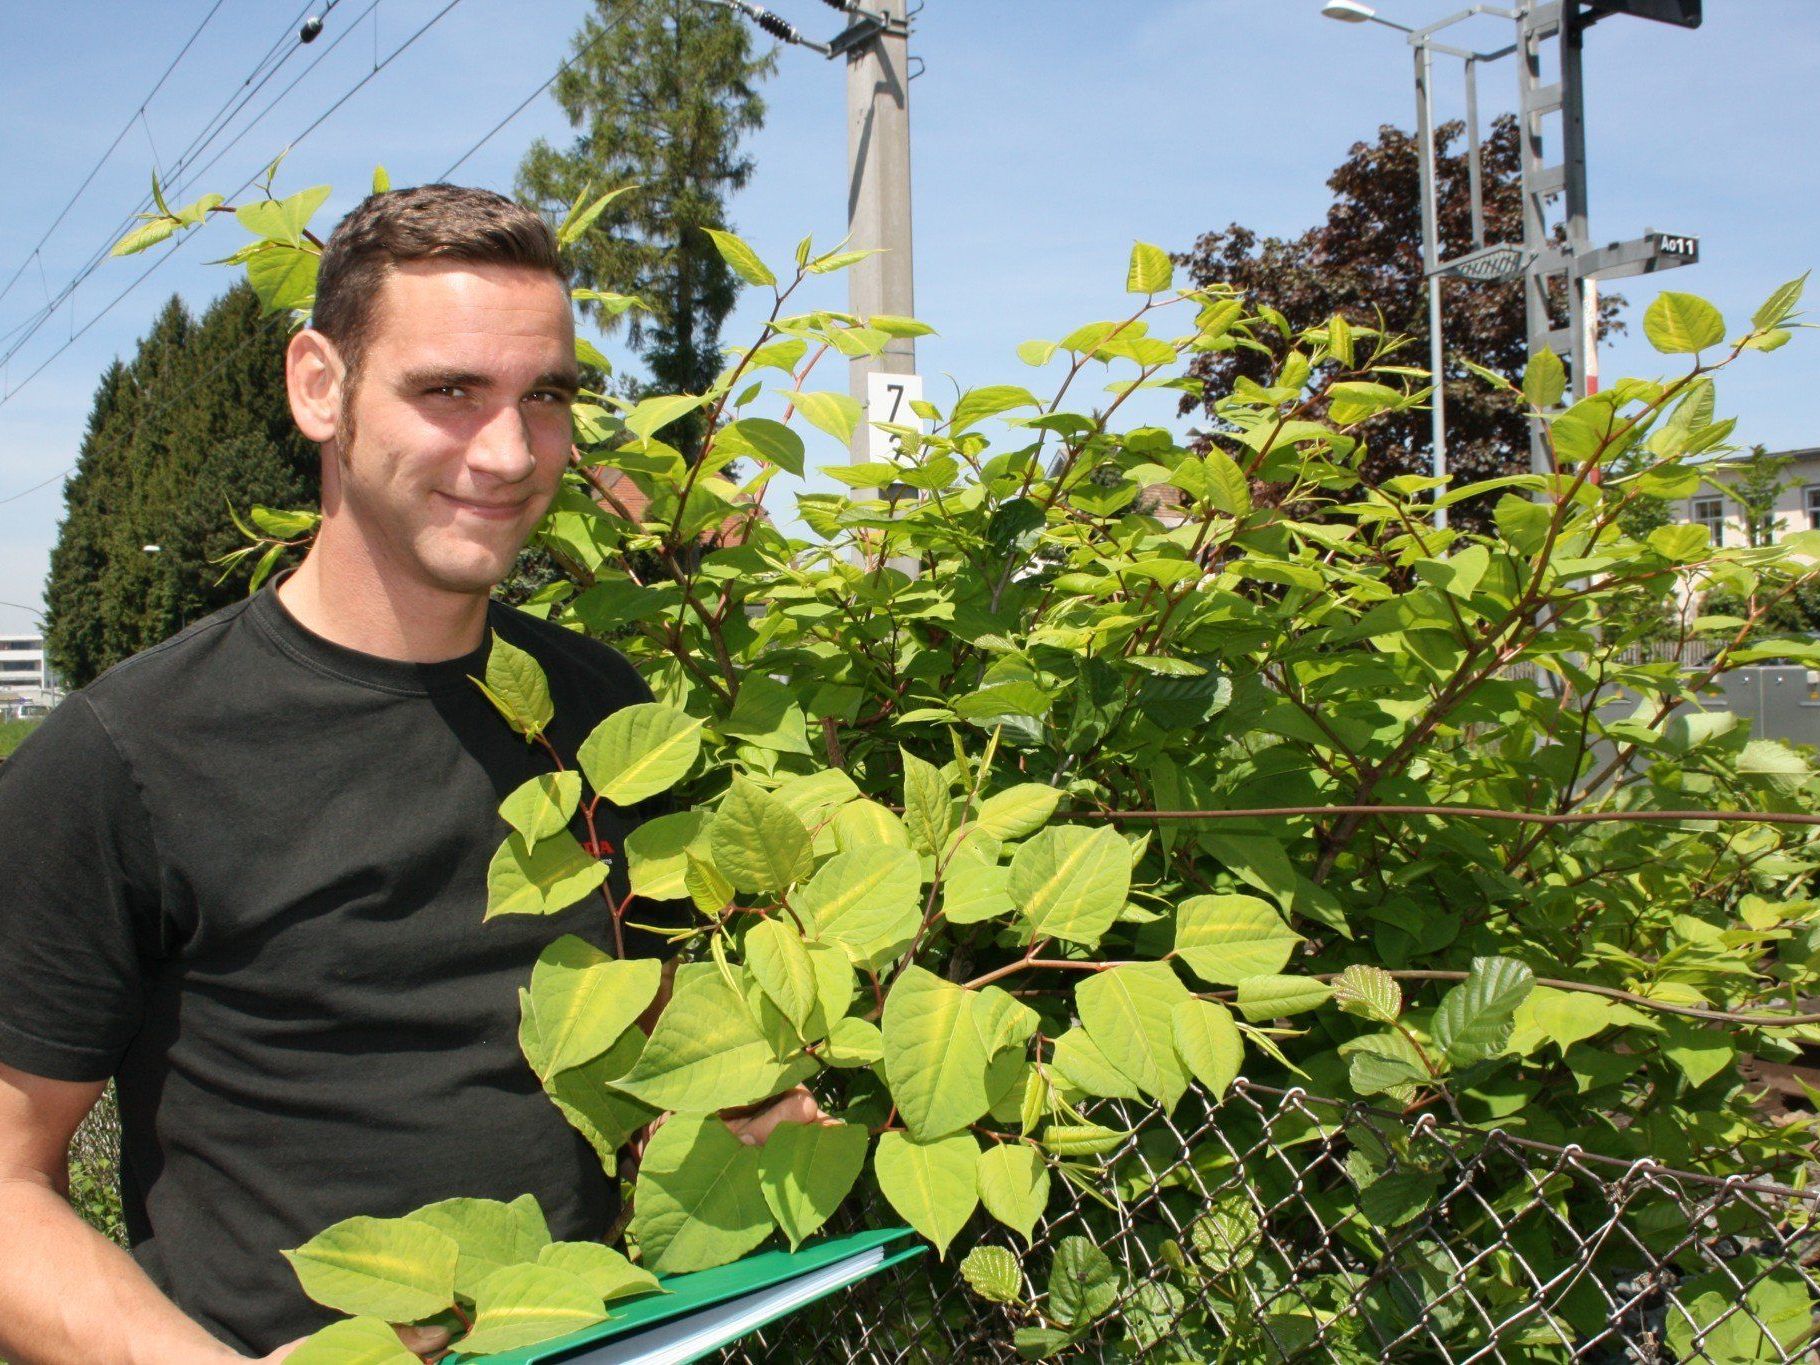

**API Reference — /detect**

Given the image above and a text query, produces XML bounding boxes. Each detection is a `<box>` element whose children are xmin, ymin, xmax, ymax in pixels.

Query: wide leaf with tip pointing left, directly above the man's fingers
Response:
<box><xmin>613</xmin><ymin>963</ymin><xmax>815</xmax><ymax>1114</ymax></box>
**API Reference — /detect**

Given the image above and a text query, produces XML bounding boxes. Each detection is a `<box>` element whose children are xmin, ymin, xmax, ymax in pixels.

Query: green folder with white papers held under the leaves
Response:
<box><xmin>450</xmin><ymin>1227</ymin><xmax>926</xmax><ymax>1365</ymax></box>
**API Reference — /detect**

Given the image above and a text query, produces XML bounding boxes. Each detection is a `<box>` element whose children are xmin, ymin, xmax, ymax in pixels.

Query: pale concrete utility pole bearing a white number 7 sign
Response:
<box><xmin>828</xmin><ymin>0</ymin><xmax>921</xmax><ymax>464</ymax></box>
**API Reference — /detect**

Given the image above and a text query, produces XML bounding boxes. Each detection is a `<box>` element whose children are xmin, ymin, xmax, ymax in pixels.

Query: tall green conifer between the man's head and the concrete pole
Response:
<box><xmin>517</xmin><ymin>0</ymin><xmax>775</xmax><ymax>433</ymax></box>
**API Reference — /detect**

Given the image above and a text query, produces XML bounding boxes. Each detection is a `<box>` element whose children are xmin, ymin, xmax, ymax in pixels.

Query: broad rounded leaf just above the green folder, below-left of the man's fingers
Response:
<box><xmin>632</xmin><ymin>1114</ymin><xmax>774</xmax><ymax>1274</ymax></box>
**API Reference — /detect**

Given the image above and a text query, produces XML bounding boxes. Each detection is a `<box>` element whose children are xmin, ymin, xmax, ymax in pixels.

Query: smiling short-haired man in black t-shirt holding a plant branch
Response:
<box><xmin>0</xmin><ymin>186</ymin><xmax>801</xmax><ymax>1365</ymax></box>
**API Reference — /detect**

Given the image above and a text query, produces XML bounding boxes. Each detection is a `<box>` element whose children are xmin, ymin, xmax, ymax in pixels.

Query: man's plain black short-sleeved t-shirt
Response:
<box><xmin>0</xmin><ymin>588</ymin><xmax>657</xmax><ymax>1354</ymax></box>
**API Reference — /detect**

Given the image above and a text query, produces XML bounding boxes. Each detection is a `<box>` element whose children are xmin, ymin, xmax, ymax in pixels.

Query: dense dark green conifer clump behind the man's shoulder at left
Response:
<box><xmin>46</xmin><ymin>284</ymin><xmax>317</xmax><ymax>686</ymax></box>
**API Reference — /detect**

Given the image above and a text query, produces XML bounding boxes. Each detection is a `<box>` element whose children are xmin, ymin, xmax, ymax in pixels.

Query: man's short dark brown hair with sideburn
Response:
<box><xmin>309</xmin><ymin>184</ymin><xmax>568</xmax><ymax>391</ymax></box>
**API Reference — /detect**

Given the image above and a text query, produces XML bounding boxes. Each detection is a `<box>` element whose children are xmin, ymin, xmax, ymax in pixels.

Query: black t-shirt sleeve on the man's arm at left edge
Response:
<box><xmin>0</xmin><ymin>693</ymin><xmax>158</xmax><ymax>1081</ymax></box>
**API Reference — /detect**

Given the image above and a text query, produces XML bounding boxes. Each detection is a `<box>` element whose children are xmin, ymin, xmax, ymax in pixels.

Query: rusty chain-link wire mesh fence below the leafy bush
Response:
<box><xmin>723</xmin><ymin>1081</ymin><xmax>1820</xmax><ymax>1365</ymax></box>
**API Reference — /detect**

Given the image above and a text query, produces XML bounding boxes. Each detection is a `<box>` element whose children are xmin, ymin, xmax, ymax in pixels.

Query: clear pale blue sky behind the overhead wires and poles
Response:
<box><xmin>0</xmin><ymin>0</ymin><xmax>1820</xmax><ymax>632</ymax></box>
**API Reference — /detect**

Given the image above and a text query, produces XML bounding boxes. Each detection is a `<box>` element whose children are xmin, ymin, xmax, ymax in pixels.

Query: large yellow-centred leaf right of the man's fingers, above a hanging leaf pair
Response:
<box><xmin>881</xmin><ymin>965</ymin><xmax>1026</xmax><ymax>1141</ymax></box>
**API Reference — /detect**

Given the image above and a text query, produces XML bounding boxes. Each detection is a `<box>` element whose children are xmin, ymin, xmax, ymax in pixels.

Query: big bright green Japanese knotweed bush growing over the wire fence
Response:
<box><xmin>134</xmin><ymin>171</ymin><xmax>1820</xmax><ymax>1354</ymax></box>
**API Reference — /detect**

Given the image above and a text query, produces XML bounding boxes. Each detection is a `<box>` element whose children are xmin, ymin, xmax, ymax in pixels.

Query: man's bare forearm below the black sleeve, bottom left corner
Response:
<box><xmin>0</xmin><ymin>1063</ymin><xmax>246</xmax><ymax>1365</ymax></box>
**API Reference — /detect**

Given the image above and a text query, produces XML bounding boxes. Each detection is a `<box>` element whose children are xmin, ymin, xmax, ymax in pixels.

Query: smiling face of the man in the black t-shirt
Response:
<box><xmin>324</xmin><ymin>262</ymin><xmax>579</xmax><ymax>593</ymax></box>
